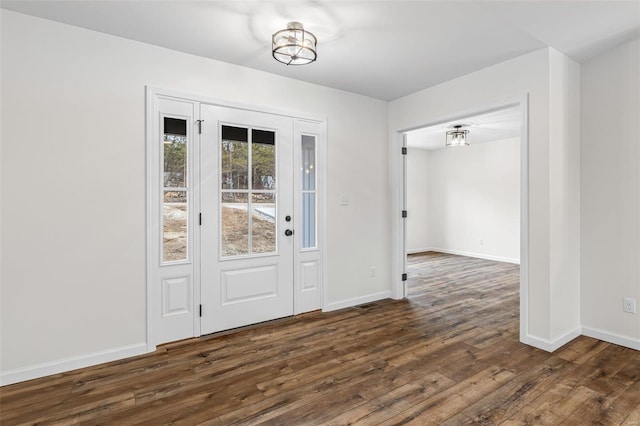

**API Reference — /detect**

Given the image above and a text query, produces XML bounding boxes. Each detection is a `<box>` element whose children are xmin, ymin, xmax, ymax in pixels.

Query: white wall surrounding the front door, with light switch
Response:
<box><xmin>0</xmin><ymin>10</ymin><xmax>391</xmax><ymax>382</ymax></box>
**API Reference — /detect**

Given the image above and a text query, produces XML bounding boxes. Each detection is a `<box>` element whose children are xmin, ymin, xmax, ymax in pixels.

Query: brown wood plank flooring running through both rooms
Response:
<box><xmin>0</xmin><ymin>253</ymin><xmax>640</xmax><ymax>426</ymax></box>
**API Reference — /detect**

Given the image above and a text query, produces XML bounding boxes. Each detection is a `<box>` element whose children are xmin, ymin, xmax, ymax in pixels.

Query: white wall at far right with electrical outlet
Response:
<box><xmin>581</xmin><ymin>40</ymin><xmax>640</xmax><ymax>349</ymax></box>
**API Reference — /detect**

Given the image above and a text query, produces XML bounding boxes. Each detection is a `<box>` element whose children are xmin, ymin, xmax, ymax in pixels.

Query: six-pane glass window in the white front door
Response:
<box><xmin>220</xmin><ymin>125</ymin><xmax>277</xmax><ymax>257</ymax></box>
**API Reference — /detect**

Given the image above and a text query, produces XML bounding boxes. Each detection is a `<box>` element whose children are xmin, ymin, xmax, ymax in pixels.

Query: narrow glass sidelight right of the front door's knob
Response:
<box><xmin>301</xmin><ymin>135</ymin><xmax>317</xmax><ymax>248</ymax></box>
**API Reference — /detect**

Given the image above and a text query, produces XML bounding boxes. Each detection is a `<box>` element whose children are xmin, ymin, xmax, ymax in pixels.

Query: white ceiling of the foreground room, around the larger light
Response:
<box><xmin>1</xmin><ymin>0</ymin><xmax>640</xmax><ymax>100</ymax></box>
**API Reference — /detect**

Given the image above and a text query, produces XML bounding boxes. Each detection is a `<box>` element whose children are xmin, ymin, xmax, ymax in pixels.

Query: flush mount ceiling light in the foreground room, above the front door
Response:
<box><xmin>271</xmin><ymin>22</ymin><xmax>318</xmax><ymax>65</ymax></box>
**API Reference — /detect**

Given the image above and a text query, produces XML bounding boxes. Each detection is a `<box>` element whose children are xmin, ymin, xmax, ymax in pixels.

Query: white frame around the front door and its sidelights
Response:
<box><xmin>145</xmin><ymin>86</ymin><xmax>328</xmax><ymax>352</ymax></box>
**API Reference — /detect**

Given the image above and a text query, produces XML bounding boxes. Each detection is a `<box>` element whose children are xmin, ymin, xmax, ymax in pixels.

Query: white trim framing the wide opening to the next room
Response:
<box><xmin>389</xmin><ymin>94</ymin><xmax>529</xmax><ymax>343</ymax></box>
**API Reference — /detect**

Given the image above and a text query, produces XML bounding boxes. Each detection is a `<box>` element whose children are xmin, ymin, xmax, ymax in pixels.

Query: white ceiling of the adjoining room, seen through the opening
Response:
<box><xmin>407</xmin><ymin>107</ymin><xmax>522</xmax><ymax>150</ymax></box>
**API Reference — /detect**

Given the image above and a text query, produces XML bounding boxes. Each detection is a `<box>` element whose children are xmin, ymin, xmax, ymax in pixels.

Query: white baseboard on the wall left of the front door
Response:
<box><xmin>0</xmin><ymin>343</ymin><xmax>148</xmax><ymax>386</ymax></box>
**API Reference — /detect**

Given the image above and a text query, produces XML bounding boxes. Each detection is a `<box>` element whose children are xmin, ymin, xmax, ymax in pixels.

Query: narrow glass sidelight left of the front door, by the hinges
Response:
<box><xmin>162</xmin><ymin>117</ymin><xmax>189</xmax><ymax>262</ymax></box>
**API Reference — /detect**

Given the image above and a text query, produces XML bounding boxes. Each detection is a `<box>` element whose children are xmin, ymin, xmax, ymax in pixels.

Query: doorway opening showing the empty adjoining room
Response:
<box><xmin>395</xmin><ymin>96</ymin><xmax>528</xmax><ymax>340</ymax></box>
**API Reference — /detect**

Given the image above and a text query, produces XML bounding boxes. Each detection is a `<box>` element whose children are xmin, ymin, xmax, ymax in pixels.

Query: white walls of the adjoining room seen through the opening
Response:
<box><xmin>407</xmin><ymin>138</ymin><xmax>520</xmax><ymax>263</ymax></box>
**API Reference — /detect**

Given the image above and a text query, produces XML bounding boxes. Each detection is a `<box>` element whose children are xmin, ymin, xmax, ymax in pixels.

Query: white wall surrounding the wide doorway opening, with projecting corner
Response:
<box><xmin>389</xmin><ymin>48</ymin><xmax>580</xmax><ymax>350</ymax></box>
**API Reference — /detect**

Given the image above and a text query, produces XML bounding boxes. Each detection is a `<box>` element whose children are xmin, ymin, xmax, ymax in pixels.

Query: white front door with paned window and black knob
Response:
<box><xmin>200</xmin><ymin>104</ymin><xmax>295</xmax><ymax>334</ymax></box>
